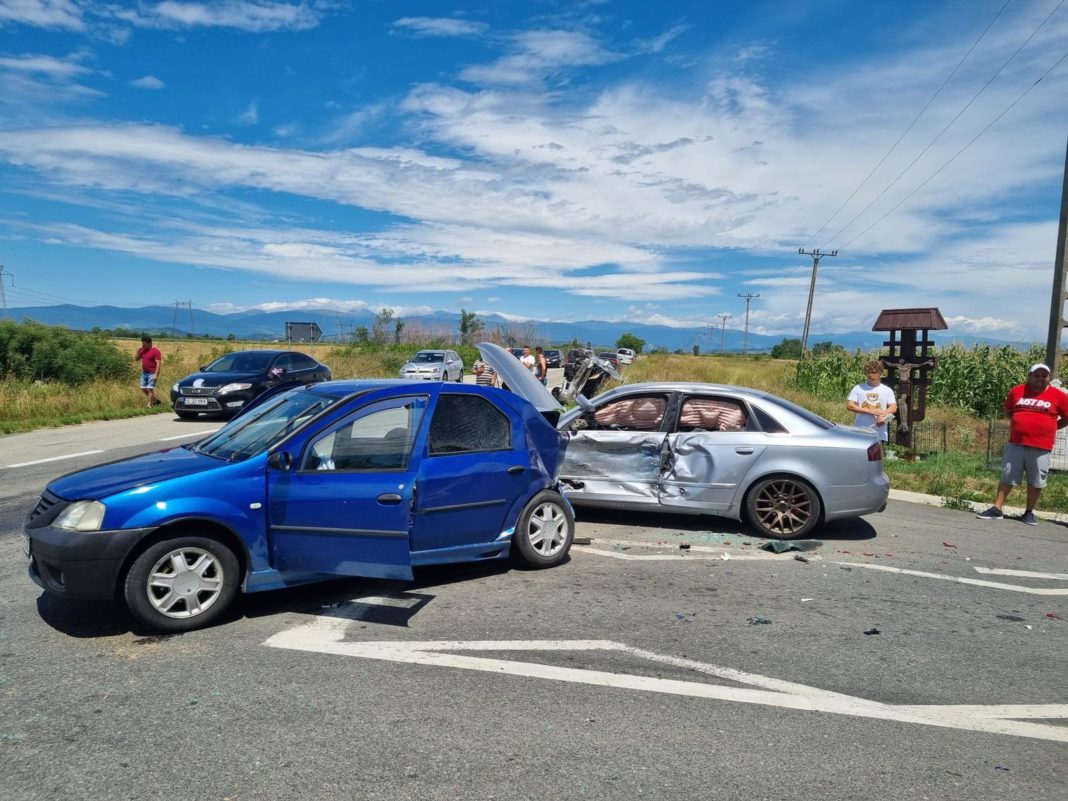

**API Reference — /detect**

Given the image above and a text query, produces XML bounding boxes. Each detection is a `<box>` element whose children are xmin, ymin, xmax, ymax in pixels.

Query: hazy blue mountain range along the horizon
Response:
<box><xmin>9</xmin><ymin>304</ymin><xmax>1030</xmax><ymax>354</ymax></box>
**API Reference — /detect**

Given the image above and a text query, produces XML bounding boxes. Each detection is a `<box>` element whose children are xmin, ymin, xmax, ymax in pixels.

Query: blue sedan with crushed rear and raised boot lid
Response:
<box><xmin>23</xmin><ymin>344</ymin><xmax>575</xmax><ymax>631</ymax></box>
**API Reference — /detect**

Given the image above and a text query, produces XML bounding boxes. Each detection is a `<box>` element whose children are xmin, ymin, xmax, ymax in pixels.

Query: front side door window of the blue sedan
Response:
<box><xmin>301</xmin><ymin>396</ymin><xmax>426</xmax><ymax>471</ymax></box>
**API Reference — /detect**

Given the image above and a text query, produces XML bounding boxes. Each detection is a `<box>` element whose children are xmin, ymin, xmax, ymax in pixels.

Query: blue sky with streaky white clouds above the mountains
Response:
<box><xmin>0</xmin><ymin>0</ymin><xmax>1068</xmax><ymax>341</ymax></box>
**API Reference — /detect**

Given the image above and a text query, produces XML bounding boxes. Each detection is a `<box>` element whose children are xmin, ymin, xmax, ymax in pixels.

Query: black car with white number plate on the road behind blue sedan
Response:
<box><xmin>171</xmin><ymin>350</ymin><xmax>330</xmax><ymax>420</ymax></box>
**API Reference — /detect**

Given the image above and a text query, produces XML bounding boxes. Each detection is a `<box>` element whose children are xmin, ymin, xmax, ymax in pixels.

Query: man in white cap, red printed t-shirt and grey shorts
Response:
<box><xmin>976</xmin><ymin>364</ymin><xmax>1068</xmax><ymax>525</ymax></box>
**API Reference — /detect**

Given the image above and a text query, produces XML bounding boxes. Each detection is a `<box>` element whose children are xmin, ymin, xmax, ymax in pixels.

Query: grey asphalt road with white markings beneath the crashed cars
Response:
<box><xmin>0</xmin><ymin>417</ymin><xmax>1068</xmax><ymax>801</ymax></box>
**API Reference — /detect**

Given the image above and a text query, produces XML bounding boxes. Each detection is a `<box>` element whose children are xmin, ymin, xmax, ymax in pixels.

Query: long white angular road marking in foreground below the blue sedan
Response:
<box><xmin>265</xmin><ymin>598</ymin><xmax>1068</xmax><ymax>742</ymax></box>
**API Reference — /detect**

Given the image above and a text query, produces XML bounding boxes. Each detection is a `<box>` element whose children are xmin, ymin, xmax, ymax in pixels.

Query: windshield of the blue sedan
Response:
<box><xmin>191</xmin><ymin>388</ymin><xmax>343</xmax><ymax>461</ymax></box>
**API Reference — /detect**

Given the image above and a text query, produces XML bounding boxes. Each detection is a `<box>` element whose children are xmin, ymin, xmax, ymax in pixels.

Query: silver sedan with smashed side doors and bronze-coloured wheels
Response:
<box><xmin>478</xmin><ymin>345</ymin><xmax>890</xmax><ymax>539</ymax></box>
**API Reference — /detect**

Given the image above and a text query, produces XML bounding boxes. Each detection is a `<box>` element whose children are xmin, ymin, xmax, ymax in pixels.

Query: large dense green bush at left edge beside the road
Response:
<box><xmin>0</xmin><ymin>320</ymin><xmax>137</xmax><ymax>384</ymax></box>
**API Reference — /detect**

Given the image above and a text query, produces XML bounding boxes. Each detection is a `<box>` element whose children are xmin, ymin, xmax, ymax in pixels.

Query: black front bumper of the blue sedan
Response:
<box><xmin>22</xmin><ymin>525</ymin><xmax>154</xmax><ymax>598</ymax></box>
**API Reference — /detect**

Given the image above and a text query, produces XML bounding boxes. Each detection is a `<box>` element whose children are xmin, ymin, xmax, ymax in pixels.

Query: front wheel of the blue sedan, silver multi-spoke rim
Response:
<box><xmin>123</xmin><ymin>536</ymin><xmax>241</xmax><ymax>633</ymax></box>
